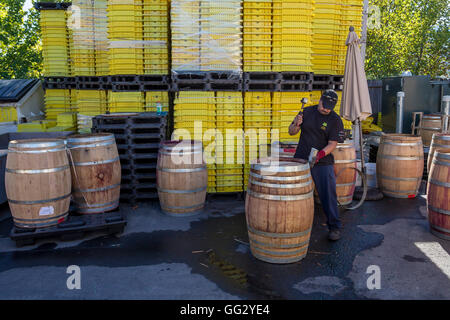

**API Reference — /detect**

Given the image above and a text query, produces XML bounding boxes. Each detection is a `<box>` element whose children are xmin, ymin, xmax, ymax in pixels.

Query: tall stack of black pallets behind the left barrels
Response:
<box><xmin>92</xmin><ymin>112</ymin><xmax>167</xmax><ymax>204</ymax></box>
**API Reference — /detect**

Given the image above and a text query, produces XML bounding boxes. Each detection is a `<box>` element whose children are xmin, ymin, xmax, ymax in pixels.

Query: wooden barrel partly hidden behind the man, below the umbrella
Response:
<box><xmin>333</xmin><ymin>143</ymin><xmax>358</xmax><ymax>205</ymax></box>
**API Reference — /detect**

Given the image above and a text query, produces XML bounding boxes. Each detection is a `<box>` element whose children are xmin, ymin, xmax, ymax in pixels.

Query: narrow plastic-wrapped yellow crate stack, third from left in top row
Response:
<box><xmin>93</xmin><ymin>0</ymin><xmax>109</xmax><ymax>76</ymax></box>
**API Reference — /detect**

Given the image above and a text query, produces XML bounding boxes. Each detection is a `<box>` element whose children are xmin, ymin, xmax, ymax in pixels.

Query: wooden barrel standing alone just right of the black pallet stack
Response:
<box><xmin>156</xmin><ymin>141</ymin><xmax>208</xmax><ymax>217</ymax></box>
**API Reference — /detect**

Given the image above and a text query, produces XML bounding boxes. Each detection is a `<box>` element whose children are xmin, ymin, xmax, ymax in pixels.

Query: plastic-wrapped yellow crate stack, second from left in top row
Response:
<box><xmin>71</xmin><ymin>0</ymin><xmax>96</xmax><ymax>76</ymax></box>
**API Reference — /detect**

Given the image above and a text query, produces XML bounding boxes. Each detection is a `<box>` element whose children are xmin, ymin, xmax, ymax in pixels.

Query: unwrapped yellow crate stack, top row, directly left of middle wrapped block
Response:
<box><xmin>142</xmin><ymin>0</ymin><xmax>169</xmax><ymax>74</ymax></box>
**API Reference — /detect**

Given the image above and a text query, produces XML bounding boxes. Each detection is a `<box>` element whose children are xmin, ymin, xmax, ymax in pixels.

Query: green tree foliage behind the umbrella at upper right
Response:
<box><xmin>366</xmin><ymin>0</ymin><xmax>450</xmax><ymax>79</ymax></box>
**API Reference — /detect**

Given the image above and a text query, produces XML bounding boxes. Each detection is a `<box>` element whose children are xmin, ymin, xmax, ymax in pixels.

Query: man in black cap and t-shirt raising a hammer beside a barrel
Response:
<box><xmin>289</xmin><ymin>90</ymin><xmax>344</xmax><ymax>241</ymax></box>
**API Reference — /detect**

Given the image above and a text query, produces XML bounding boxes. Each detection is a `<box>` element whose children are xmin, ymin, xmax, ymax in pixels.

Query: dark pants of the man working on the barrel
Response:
<box><xmin>311</xmin><ymin>165</ymin><xmax>341</xmax><ymax>231</ymax></box>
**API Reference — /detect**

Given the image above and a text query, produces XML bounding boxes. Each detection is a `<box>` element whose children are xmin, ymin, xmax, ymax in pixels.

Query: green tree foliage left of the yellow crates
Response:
<box><xmin>0</xmin><ymin>0</ymin><xmax>42</xmax><ymax>79</ymax></box>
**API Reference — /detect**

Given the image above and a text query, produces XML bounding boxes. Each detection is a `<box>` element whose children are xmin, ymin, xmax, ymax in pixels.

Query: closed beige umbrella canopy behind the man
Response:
<box><xmin>341</xmin><ymin>27</ymin><xmax>372</xmax><ymax>122</ymax></box>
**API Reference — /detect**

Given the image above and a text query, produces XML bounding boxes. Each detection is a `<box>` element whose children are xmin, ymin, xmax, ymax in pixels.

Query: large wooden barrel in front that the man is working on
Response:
<box><xmin>245</xmin><ymin>158</ymin><xmax>314</xmax><ymax>264</ymax></box>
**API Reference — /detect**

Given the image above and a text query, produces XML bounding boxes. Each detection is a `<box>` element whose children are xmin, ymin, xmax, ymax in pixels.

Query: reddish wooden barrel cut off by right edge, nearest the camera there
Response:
<box><xmin>427</xmin><ymin>149</ymin><xmax>450</xmax><ymax>240</ymax></box>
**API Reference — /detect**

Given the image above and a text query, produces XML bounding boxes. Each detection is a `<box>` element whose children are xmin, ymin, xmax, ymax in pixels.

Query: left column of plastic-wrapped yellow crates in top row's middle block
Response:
<box><xmin>171</xmin><ymin>0</ymin><xmax>200</xmax><ymax>72</ymax></box>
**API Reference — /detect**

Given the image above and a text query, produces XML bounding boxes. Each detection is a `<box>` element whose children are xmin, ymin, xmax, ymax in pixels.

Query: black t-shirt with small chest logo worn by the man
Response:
<box><xmin>294</xmin><ymin>105</ymin><xmax>344</xmax><ymax>166</ymax></box>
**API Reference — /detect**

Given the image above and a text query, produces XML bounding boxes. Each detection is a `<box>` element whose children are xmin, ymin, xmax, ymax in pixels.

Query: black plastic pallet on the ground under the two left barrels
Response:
<box><xmin>10</xmin><ymin>210</ymin><xmax>127</xmax><ymax>247</ymax></box>
